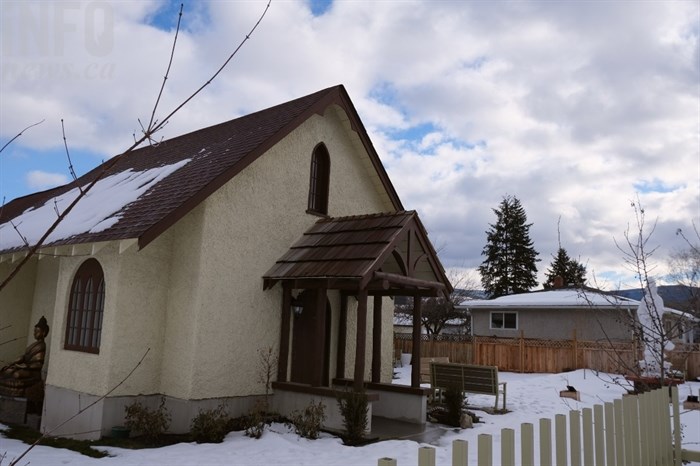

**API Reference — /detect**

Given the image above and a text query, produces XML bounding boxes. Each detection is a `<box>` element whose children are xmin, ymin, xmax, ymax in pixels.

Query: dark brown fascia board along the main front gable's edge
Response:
<box><xmin>138</xmin><ymin>84</ymin><xmax>403</xmax><ymax>249</ymax></box>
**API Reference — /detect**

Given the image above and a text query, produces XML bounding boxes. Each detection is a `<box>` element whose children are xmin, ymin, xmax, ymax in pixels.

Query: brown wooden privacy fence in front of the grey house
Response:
<box><xmin>394</xmin><ymin>334</ymin><xmax>700</xmax><ymax>379</ymax></box>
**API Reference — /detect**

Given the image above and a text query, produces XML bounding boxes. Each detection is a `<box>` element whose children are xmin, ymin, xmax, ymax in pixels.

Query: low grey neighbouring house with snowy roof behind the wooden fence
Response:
<box><xmin>459</xmin><ymin>287</ymin><xmax>697</xmax><ymax>343</ymax></box>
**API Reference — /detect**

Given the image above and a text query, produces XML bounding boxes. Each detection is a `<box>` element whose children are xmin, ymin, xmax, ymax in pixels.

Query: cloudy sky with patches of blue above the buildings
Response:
<box><xmin>0</xmin><ymin>0</ymin><xmax>700</xmax><ymax>288</ymax></box>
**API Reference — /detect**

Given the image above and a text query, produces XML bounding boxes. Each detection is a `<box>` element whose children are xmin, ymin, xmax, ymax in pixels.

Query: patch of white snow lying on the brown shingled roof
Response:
<box><xmin>0</xmin><ymin>159</ymin><xmax>191</xmax><ymax>251</ymax></box>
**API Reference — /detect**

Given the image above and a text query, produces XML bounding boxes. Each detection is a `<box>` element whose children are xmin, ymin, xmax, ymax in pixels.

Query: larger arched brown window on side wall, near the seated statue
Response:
<box><xmin>64</xmin><ymin>259</ymin><xmax>105</xmax><ymax>353</ymax></box>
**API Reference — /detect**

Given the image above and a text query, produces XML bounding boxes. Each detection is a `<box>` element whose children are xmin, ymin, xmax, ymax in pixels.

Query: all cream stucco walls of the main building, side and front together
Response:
<box><xmin>32</xmin><ymin>103</ymin><xmax>404</xmax><ymax>438</ymax></box>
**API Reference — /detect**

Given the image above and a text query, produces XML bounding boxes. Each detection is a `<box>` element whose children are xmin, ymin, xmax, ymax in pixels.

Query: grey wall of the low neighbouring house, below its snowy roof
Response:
<box><xmin>470</xmin><ymin>308</ymin><xmax>632</xmax><ymax>341</ymax></box>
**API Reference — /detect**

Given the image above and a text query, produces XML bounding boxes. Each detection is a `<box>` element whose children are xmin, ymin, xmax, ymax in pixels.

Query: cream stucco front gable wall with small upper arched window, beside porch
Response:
<box><xmin>183</xmin><ymin>106</ymin><xmax>391</xmax><ymax>398</ymax></box>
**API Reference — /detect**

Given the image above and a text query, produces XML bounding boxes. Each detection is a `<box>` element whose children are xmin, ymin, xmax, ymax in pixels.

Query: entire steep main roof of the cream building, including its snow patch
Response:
<box><xmin>0</xmin><ymin>85</ymin><xmax>403</xmax><ymax>254</ymax></box>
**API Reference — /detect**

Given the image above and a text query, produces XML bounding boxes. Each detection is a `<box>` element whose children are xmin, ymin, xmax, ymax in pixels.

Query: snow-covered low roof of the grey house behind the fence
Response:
<box><xmin>457</xmin><ymin>288</ymin><xmax>690</xmax><ymax>318</ymax></box>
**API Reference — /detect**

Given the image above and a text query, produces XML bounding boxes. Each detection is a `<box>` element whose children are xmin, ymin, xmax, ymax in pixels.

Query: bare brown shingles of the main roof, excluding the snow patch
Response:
<box><xmin>0</xmin><ymin>86</ymin><xmax>402</xmax><ymax>253</ymax></box>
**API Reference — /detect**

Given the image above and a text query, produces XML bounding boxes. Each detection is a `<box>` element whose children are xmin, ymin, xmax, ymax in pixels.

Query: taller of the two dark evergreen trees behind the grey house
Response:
<box><xmin>479</xmin><ymin>196</ymin><xmax>539</xmax><ymax>298</ymax></box>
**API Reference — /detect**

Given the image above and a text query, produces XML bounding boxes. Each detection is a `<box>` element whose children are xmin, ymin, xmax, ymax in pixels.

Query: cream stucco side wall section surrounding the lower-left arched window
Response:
<box><xmin>44</xmin><ymin>234</ymin><xmax>178</xmax><ymax>395</ymax></box>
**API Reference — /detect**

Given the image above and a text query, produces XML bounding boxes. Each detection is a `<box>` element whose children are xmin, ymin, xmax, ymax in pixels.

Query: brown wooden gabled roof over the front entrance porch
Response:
<box><xmin>263</xmin><ymin>211</ymin><xmax>452</xmax><ymax>296</ymax></box>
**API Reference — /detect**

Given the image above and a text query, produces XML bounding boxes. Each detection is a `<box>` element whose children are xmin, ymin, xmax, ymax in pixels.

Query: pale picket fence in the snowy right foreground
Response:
<box><xmin>378</xmin><ymin>387</ymin><xmax>700</xmax><ymax>466</ymax></box>
